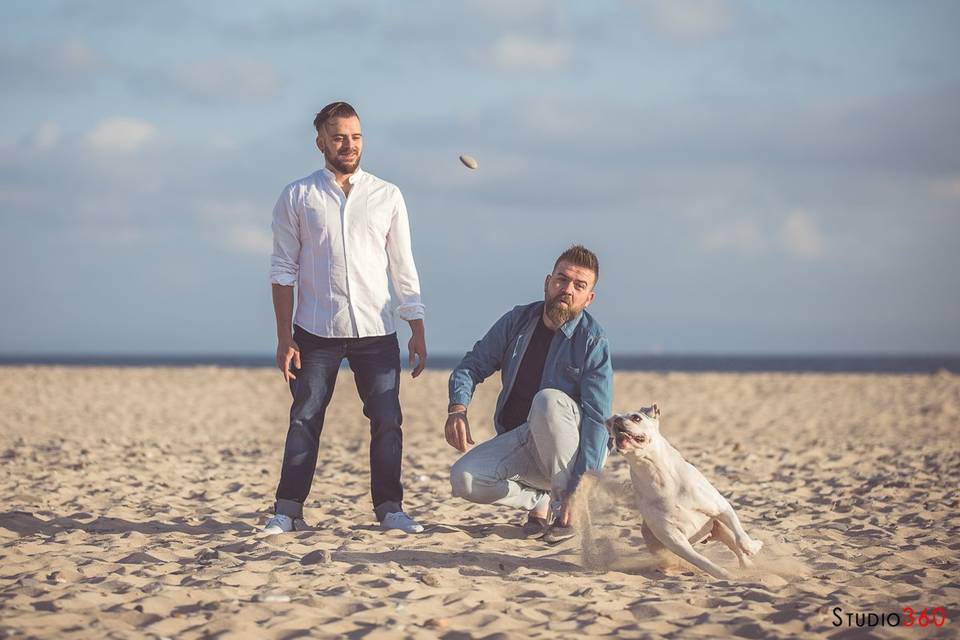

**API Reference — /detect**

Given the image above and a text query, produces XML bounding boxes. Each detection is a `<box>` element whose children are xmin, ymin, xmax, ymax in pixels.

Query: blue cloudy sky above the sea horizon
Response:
<box><xmin>0</xmin><ymin>0</ymin><xmax>960</xmax><ymax>354</ymax></box>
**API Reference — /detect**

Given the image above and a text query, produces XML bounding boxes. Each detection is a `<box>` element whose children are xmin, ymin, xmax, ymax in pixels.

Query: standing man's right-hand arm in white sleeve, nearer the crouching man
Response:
<box><xmin>386</xmin><ymin>189</ymin><xmax>427</xmax><ymax>378</ymax></box>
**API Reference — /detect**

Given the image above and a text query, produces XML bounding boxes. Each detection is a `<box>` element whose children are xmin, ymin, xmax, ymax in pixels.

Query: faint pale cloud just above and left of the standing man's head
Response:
<box><xmin>170</xmin><ymin>58</ymin><xmax>281</xmax><ymax>99</ymax></box>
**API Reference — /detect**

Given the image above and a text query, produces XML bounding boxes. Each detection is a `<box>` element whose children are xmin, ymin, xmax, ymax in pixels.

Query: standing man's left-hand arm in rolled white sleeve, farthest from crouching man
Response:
<box><xmin>270</xmin><ymin>188</ymin><xmax>300</xmax><ymax>382</ymax></box>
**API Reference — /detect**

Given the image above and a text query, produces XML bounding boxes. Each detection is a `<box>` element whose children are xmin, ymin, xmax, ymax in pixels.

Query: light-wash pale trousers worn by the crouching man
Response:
<box><xmin>450</xmin><ymin>389</ymin><xmax>580</xmax><ymax>510</ymax></box>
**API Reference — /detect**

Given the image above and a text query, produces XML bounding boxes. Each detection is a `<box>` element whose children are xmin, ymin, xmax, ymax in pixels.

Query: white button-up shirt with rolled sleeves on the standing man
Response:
<box><xmin>270</xmin><ymin>168</ymin><xmax>424</xmax><ymax>338</ymax></box>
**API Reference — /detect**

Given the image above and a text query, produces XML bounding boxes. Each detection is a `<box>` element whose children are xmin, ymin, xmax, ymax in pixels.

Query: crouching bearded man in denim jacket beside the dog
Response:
<box><xmin>444</xmin><ymin>245</ymin><xmax>613</xmax><ymax>543</ymax></box>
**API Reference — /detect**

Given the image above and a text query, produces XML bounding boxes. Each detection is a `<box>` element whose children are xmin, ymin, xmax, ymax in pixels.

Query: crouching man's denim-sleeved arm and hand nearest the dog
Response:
<box><xmin>559</xmin><ymin>336</ymin><xmax>613</xmax><ymax>526</ymax></box>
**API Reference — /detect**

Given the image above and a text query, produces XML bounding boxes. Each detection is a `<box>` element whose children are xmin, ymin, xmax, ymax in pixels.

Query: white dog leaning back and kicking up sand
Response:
<box><xmin>606</xmin><ymin>405</ymin><xmax>763</xmax><ymax>578</ymax></box>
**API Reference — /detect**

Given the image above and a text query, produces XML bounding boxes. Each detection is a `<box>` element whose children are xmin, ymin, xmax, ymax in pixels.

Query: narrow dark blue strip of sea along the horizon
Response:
<box><xmin>0</xmin><ymin>354</ymin><xmax>960</xmax><ymax>373</ymax></box>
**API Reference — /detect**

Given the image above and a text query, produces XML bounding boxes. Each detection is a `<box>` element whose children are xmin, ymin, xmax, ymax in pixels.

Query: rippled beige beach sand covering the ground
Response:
<box><xmin>0</xmin><ymin>367</ymin><xmax>960</xmax><ymax>639</ymax></box>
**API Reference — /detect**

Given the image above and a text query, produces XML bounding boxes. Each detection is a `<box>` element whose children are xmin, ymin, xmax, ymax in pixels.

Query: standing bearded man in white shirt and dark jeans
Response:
<box><xmin>264</xmin><ymin>102</ymin><xmax>427</xmax><ymax>534</ymax></box>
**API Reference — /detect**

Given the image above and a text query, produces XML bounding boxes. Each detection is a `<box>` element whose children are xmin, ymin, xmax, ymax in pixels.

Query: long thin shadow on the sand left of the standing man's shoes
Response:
<box><xmin>0</xmin><ymin>511</ymin><xmax>250</xmax><ymax>536</ymax></box>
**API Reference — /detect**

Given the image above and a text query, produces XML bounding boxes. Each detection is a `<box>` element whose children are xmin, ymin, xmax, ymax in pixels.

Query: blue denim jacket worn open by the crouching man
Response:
<box><xmin>449</xmin><ymin>301</ymin><xmax>613</xmax><ymax>492</ymax></box>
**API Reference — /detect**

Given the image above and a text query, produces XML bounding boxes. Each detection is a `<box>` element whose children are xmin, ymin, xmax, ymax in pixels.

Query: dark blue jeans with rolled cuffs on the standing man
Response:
<box><xmin>276</xmin><ymin>326</ymin><xmax>403</xmax><ymax>521</ymax></box>
